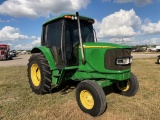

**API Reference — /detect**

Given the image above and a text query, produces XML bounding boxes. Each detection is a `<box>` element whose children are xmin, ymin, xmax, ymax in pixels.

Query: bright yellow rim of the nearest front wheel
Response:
<box><xmin>80</xmin><ymin>90</ymin><xmax>94</xmax><ymax>109</ymax></box>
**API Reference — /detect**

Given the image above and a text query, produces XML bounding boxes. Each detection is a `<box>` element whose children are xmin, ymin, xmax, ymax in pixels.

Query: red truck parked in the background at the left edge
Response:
<box><xmin>0</xmin><ymin>44</ymin><xmax>12</xmax><ymax>60</ymax></box>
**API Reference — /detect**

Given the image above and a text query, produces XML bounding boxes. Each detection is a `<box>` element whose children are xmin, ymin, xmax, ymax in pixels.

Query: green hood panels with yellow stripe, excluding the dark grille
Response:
<box><xmin>79</xmin><ymin>42</ymin><xmax>131</xmax><ymax>74</ymax></box>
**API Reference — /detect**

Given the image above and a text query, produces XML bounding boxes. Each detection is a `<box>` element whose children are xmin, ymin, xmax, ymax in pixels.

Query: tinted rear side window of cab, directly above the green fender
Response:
<box><xmin>42</xmin><ymin>19</ymin><xmax>65</xmax><ymax>69</ymax></box>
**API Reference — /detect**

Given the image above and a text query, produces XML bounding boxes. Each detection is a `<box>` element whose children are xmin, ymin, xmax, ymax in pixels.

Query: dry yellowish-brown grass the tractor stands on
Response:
<box><xmin>0</xmin><ymin>58</ymin><xmax>160</xmax><ymax>120</ymax></box>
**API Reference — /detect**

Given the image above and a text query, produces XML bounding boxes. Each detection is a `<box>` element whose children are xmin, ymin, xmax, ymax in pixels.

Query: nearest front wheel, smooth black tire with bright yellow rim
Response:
<box><xmin>76</xmin><ymin>80</ymin><xmax>107</xmax><ymax>116</ymax></box>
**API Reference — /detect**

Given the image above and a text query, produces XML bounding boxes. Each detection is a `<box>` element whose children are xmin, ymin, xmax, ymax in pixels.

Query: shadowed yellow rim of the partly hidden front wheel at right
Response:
<box><xmin>117</xmin><ymin>80</ymin><xmax>130</xmax><ymax>92</ymax></box>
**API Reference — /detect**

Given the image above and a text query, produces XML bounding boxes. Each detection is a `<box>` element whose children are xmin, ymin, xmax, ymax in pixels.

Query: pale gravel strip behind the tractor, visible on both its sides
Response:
<box><xmin>0</xmin><ymin>53</ymin><xmax>160</xmax><ymax>67</ymax></box>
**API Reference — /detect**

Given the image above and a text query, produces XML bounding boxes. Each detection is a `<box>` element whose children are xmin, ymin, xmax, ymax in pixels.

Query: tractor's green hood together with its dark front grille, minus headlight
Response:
<box><xmin>79</xmin><ymin>42</ymin><xmax>132</xmax><ymax>73</ymax></box>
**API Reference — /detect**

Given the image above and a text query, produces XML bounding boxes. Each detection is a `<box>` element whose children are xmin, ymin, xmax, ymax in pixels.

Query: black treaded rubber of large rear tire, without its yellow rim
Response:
<box><xmin>27</xmin><ymin>53</ymin><xmax>52</xmax><ymax>94</ymax></box>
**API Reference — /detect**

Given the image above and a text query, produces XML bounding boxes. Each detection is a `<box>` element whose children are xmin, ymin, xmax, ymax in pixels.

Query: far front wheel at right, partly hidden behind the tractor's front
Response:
<box><xmin>113</xmin><ymin>73</ymin><xmax>139</xmax><ymax>97</ymax></box>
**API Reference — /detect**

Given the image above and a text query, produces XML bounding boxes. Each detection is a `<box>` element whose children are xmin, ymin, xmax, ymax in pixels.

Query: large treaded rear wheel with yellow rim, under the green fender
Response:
<box><xmin>27</xmin><ymin>53</ymin><xmax>52</xmax><ymax>94</ymax></box>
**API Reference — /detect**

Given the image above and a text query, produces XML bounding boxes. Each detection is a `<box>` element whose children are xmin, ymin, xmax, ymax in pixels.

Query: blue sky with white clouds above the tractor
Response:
<box><xmin>0</xmin><ymin>0</ymin><xmax>160</xmax><ymax>50</ymax></box>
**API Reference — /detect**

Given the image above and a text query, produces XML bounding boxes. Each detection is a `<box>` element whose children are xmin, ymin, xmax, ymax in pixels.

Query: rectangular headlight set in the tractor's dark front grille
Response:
<box><xmin>116</xmin><ymin>57</ymin><xmax>132</xmax><ymax>65</ymax></box>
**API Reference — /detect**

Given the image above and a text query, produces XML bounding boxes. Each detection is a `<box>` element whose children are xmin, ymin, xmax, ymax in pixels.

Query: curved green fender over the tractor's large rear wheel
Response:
<box><xmin>31</xmin><ymin>46</ymin><xmax>56</xmax><ymax>70</ymax></box>
